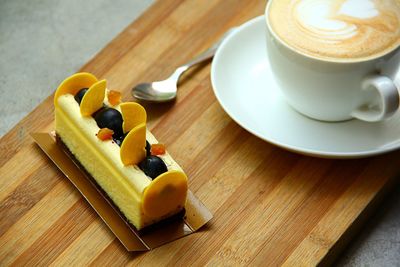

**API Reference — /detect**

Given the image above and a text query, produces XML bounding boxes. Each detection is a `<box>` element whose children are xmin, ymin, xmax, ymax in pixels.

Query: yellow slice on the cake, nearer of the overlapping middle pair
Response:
<box><xmin>120</xmin><ymin>123</ymin><xmax>146</xmax><ymax>166</ymax></box>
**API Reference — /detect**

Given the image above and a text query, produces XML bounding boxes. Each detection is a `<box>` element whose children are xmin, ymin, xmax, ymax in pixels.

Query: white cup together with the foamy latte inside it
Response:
<box><xmin>265</xmin><ymin>0</ymin><xmax>400</xmax><ymax>122</ymax></box>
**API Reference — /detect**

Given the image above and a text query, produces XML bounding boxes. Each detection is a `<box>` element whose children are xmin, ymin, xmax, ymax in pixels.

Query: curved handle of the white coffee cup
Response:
<box><xmin>351</xmin><ymin>75</ymin><xmax>399</xmax><ymax>122</ymax></box>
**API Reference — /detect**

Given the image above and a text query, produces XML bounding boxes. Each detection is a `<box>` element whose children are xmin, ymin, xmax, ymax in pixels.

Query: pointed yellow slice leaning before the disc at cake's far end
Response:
<box><xmin>80</xmin><ymin>80</ymin><xmax>107</xmax><ymax>117</ymax></box>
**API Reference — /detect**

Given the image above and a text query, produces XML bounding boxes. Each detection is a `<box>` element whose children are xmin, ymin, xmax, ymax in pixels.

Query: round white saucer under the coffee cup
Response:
<box><xmin>211</xmin><ymin>16</ymin><xmax>400</xmax><ymax>158</ymax></box>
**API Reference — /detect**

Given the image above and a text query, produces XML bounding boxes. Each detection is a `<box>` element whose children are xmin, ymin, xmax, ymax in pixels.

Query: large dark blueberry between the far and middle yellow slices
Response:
<box><xmin>94</xmin><ymin>108</ymin><xmax>123</xmax><ymax>137</ymax></box>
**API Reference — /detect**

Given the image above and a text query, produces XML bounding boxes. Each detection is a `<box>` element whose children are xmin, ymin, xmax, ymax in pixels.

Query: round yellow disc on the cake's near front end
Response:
<box><xmin>142</xmin><ymin>170</ymin><xmax>188</xmax><ymax>218</ymax></box>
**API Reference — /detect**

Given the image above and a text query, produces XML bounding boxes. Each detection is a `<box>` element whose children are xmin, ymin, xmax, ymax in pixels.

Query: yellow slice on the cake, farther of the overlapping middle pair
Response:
<box><xmin>120</xmin><ymin>102</ymin><xmax>147</xmax><ymax>133</ymax></box>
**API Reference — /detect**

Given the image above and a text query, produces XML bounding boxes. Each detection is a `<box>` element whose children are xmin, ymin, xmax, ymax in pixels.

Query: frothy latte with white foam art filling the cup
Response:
<box><xmin>266</xmin><ymin>0</ymin><xmax>400</xmax><ymax>62</ymax></box>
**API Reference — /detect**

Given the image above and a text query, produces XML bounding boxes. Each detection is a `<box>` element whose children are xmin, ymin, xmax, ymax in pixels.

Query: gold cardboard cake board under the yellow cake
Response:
<box><xmin>31</xmin><ymin>133</ymin><xmax>212</xmax><ymax>251</ymax></box>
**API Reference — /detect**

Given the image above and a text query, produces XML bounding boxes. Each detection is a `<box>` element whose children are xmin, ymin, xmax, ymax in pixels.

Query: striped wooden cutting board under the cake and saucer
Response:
<box><xmin>0</xmin><ymin>0</ymin><xmax>400</xmax><ymax>266</ymax></box>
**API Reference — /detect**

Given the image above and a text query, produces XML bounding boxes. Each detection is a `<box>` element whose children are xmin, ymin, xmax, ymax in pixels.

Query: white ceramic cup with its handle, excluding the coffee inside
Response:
<box><xmin>265</xmin><ymin>0</ymin><xmax>400</xmax><ymax>122</ymax></box>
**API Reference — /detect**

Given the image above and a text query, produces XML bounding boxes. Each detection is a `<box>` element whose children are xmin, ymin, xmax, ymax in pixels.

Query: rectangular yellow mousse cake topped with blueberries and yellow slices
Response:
<box><xmin>54</xmin><ymin>73</ymin><xmax>188</xmax><ymax>230</ymax></box>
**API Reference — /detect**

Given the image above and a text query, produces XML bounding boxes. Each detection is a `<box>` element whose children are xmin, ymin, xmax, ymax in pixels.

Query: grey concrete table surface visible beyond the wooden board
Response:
<box><xmin>0</xmin><ymin>0</ymin><xmax>400</xmax><ymax>266</ymax></box>
